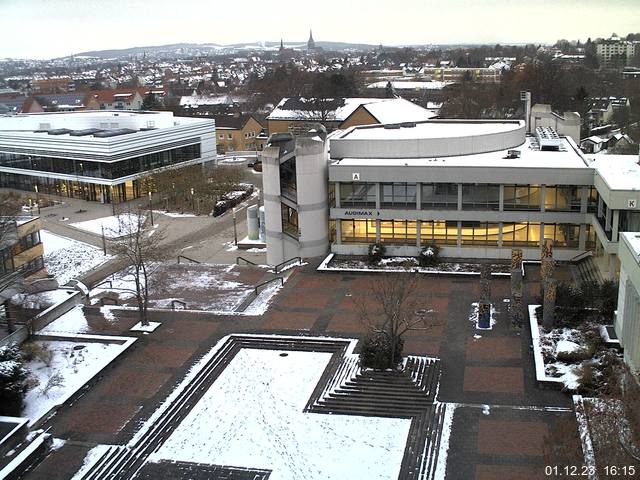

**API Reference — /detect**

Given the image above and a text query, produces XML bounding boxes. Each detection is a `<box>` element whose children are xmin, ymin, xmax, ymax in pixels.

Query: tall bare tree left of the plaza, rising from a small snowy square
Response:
<box><xmin>110</xmin><ymin>210</ymin><xmax>165</xmax><ymax>325</ymax></box>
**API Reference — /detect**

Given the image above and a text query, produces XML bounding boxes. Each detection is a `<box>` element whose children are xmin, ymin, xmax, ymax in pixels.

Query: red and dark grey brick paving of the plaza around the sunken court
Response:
<box><xmin>26</xmin><ymin>265</ymin><xmax>572</xmax><ymax>480</ymax></box>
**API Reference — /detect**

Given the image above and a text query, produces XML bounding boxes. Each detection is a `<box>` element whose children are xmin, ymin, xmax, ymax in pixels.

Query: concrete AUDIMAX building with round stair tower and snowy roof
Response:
<box><xmin>263</xmin><ymin>120</ymin><xmax>640</xmax><ymax>277</ymax></box>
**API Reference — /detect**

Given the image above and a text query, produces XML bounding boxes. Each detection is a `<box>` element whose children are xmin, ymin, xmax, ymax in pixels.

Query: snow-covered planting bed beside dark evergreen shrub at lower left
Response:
<box><xmin>22</xmin><ymin>339</ymin><xmax>131</xmax><ymax>423</ymax></box>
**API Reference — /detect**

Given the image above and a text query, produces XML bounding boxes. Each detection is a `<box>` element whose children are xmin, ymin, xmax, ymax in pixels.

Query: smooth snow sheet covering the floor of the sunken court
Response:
<box><xmin>149</xmin><ymin>349</ymin><xmax>411</xmax><ymax>480</ymax></box>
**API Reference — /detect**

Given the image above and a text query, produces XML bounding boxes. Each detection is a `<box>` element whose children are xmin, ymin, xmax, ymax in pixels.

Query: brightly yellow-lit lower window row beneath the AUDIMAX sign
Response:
<box><xmin>340</xmin><ymin>219</ymin><xmax>595</xmax><ymax>249</ymax></box>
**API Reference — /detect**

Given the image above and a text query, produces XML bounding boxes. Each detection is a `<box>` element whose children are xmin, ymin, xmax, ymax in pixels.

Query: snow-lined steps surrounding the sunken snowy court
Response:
<box><xmin>79</xmin><ymin>335</ymin><xmax>447</xmax><ymax>480</ymax></box>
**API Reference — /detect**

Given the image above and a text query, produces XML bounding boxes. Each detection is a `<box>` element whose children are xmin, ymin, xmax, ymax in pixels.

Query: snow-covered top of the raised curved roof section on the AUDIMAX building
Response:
<box><xmin>340</xmin><ymin>120</ymin><xmax>522</xmax><ymax>140</ymax></box>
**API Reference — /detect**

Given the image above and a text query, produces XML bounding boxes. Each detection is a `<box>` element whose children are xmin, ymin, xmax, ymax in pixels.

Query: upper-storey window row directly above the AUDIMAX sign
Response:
<box><xmin>340</xmin><ymin>182</ymin><xmax>597</xmax><ymax>212</ymax></box>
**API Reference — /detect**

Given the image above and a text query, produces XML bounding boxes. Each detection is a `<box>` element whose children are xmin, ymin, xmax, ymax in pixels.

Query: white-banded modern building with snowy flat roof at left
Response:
<box><xmin>0</xmin><ymin>111</ymin><xmax>216</xmax><ymax>202</ymax></box>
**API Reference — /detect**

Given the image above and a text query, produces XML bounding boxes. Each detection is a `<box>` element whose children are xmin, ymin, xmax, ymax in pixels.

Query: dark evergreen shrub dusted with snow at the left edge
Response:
<box><xmin>0</xmin><ymin>344</ymin><xmax>29</xmax><ymax>416</ymax></box>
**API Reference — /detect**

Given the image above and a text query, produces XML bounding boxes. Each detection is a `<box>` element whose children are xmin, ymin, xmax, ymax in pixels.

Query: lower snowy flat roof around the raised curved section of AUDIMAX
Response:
<box><xmin>331</xmin><ymin>136</ymin><xmax>589</xmax><ymax>169</ymax></box>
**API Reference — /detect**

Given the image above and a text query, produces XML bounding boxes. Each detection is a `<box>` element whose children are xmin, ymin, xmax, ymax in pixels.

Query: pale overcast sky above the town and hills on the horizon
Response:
<box><xmin>0</xmin><ymin>0</ymin><xmax>640</xmax><ymax>58</ymax></box>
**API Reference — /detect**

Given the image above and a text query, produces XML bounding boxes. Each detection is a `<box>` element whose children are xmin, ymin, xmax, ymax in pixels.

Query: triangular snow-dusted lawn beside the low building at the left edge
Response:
<box><xmin>40</xmin><ymin>230</ymin><xmax>113</xmax><ymax>285</ymax></box>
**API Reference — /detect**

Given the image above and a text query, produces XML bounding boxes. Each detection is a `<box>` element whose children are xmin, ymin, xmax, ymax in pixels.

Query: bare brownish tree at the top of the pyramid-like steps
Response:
<box><xmin>354</xmin><ymin>273</ymin><xmax>438</xmax><ymax>368</ymax></box>
